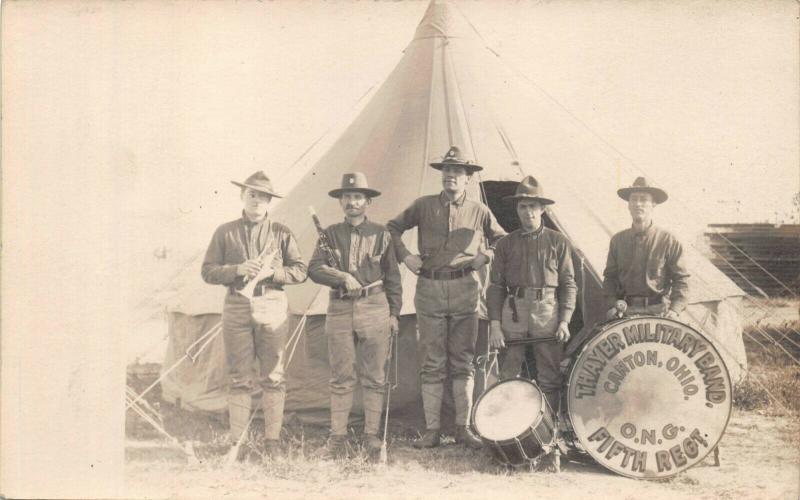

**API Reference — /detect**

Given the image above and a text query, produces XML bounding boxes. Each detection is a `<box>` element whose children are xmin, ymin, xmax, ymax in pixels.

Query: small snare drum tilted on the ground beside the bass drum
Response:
<box><xmin>472</xmin><ymin>378</ymin><xmax>555</xmax><ymax>466</ymax></box>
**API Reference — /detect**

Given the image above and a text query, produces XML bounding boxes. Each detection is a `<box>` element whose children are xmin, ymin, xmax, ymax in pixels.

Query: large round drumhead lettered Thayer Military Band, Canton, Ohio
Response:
<box><xmin>567</xmin><ymin>316</ymin><xmax>732</xmax><ymax>479</ymax></box>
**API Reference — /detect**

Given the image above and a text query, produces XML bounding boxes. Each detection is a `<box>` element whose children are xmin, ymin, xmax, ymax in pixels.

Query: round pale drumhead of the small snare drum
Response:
<box><xmin>472</xmin><ymin>379</ymin><xmax>542</xmax><ymax>441</ymax></box>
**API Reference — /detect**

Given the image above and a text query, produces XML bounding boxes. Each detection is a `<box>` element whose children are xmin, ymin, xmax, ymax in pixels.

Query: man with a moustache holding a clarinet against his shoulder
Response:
<box><xmin>308</xmin><ymin>172</ymin><xmax>403</xmax><ymax>457</ymax></box>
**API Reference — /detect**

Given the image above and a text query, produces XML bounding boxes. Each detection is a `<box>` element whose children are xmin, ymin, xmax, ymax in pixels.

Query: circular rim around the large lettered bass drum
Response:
<box><xmin>566</xmin><ymin>314</ymin><xmax>733</xmax><ymax>481</ymax></box>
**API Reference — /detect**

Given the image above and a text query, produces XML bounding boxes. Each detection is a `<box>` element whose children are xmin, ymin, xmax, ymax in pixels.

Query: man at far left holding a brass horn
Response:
<box><xmin>201</xmin><ymin>171</ymin><xmax>306</xmax><ymax>458</ymax></box>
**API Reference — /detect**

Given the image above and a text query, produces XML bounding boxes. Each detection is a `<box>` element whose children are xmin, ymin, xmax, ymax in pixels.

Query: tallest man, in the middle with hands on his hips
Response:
<box><xmin>387</xmin><ymin>146</ymin><xmax>505</xmax><ymax>448</ymax></box>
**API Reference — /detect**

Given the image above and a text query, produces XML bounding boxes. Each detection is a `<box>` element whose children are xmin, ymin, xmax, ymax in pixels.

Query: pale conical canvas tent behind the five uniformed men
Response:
<box><xmin>155</xmin><ymin>0</ymin><xmax>746</xmax><ymax>426</ymax></box>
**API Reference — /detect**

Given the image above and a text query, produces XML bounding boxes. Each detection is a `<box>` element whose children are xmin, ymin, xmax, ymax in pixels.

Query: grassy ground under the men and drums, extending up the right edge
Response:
<box><xmin>126</xmin><ymin>302</ymin><xmax>800</xmax><ymax>500</ymax></box>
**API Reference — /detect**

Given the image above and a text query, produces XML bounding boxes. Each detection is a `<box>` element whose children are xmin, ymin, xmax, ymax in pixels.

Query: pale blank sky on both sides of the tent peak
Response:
<box><xmin>3</xmin><ymin>1</ymin><xmax>800</xmax><ymax>296</ymax></box>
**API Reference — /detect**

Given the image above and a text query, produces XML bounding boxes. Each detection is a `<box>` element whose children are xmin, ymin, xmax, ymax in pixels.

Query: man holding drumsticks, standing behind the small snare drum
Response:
<box><xmin>487</xmin><ymin>176</ymin><xmax>577</xmax><ymax>411</ymax></box>
